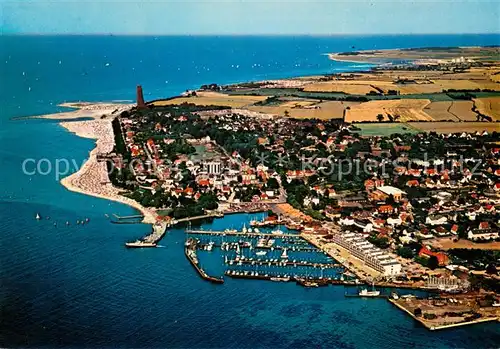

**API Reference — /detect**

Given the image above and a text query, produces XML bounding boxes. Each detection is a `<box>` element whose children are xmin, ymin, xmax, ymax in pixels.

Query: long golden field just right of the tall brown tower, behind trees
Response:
<box><xmin>153</xmin><ymin>92</ymin><xmax>267</xmax><ymax>108</ymax></box>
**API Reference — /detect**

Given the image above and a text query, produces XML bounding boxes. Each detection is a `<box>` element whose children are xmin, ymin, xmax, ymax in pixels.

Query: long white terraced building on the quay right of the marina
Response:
<box><xmin>333</xmin><ymin>232</ymin><xmax>401</xmax><ymax>276</ymax></box>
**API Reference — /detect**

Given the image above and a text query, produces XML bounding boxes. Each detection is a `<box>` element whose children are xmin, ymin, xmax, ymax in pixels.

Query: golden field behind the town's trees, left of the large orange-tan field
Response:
<box><xmin>246</xmin><ymin>101</ymin><xmax>359</xmax><ymax>120</ymax></box>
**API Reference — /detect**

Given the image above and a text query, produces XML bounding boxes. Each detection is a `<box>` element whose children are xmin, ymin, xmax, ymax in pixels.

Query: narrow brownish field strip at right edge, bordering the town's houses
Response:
<box><xmin>407</xmin><ymin>122</ymin><xmax>500</xmax><ymax>133</ymax></box>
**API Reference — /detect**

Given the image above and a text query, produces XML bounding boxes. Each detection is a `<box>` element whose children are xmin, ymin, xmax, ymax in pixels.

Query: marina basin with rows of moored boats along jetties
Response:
<box><xmin>186</xmin><ymin>224</ymin><xmax>355</xmax><ymax>287</ymax></box>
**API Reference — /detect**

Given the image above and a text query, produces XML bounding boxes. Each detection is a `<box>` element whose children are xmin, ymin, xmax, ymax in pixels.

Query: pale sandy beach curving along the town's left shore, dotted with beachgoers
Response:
<box><xmin>60</xmin><ymin>119</ymin><xmax>156</xmax><ymax>224</ymax></box>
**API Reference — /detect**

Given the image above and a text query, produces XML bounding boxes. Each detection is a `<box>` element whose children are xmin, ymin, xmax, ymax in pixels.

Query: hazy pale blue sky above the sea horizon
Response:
<box><xmin>0</xmin><ymin>0</ymin><xmax>500</xmax><ymax>35</ymax></box>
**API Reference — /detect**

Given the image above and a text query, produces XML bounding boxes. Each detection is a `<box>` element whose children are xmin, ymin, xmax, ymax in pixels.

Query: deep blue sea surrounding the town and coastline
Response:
<box><xmin>0</xmin><ymin>35</ymin><xmax>500</xmax><ymax>348</ymax></box>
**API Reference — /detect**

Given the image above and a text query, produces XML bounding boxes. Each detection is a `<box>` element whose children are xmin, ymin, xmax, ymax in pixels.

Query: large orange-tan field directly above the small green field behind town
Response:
<box><xmin>345</xmin><ymin>99</ymin><xmax>433</xmax><ymax>122</ymax></box>
